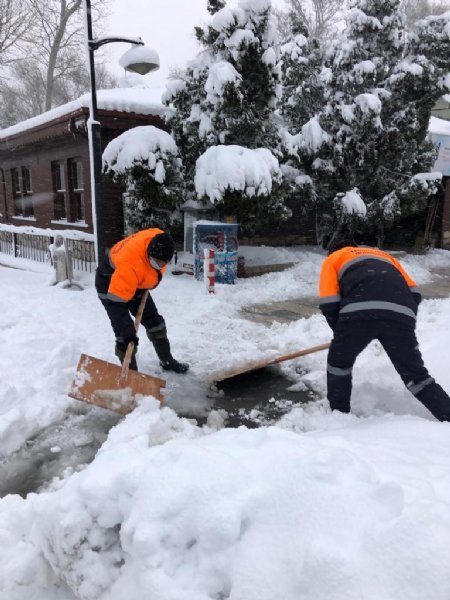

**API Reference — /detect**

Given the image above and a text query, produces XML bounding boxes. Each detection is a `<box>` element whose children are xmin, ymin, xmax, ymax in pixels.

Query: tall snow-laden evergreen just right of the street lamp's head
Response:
<box><xmin>164</xmin><ymin>0</ymin><xmax>279</xmax><ymax>232</ymax></box>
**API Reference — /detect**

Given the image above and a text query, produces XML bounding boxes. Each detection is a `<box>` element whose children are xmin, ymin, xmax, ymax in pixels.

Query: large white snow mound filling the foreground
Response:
<box><xmin>4</xmin><ymin>402</ymin><xmax>450</xmax><ymax>600</ymax></box>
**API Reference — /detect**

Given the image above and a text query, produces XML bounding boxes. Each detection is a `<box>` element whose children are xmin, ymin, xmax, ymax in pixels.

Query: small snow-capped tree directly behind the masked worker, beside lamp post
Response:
<box><xmin>103</xmin><ymin>125</ymin><xmax>181</xmax><ymax>233</ymax></box>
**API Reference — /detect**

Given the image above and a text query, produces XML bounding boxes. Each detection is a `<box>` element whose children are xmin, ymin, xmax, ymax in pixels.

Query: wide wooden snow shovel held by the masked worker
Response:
<box><xmin>69</xmin><ymin>290</ymin><xmax>166</xmax><ymax>415</ymax></box>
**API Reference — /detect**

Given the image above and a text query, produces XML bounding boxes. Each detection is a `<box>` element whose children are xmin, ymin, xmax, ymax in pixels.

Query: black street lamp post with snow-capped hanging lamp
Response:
<box><xmin>85</xmin><ymin>0</ymin><xmax>159</xmax><ymax>265</ymax></box>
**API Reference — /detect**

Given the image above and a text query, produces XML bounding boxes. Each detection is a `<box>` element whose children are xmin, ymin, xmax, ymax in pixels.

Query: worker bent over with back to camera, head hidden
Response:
<box><xmin>320</xmin><ymin>237</ymin><xmax>450</xmax><ymax>421</ymax></box>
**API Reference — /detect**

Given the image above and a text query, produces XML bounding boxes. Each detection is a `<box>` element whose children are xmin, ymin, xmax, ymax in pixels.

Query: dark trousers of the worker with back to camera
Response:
<box><xmin>327</xmin><ymin>319</ymin><xmax>450</xmax><ymax>421</ymax></box>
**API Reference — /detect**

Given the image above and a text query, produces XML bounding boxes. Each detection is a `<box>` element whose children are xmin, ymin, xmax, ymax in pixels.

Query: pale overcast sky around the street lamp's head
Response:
<box><xmin>105</xmin><ymin>0</ymin><xmax>284</xmax><ymax>86</ymax></box>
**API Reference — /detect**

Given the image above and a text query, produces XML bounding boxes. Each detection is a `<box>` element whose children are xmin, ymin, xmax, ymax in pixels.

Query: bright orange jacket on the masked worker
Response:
<box><xmin>106</xmin><ymin>228</ymin><xmax>166</xmax><ymax>302</ymax></box>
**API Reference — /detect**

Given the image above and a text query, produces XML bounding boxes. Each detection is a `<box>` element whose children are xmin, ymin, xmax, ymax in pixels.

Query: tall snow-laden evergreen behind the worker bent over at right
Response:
<box><xmin>295</xmin><ymin>0</ymin><xmax>449</xmax><ymax>244</ymax></box>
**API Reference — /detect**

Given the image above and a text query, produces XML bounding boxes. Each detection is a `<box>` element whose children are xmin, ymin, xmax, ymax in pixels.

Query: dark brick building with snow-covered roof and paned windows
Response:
<box><xmin>0</xmin><ymin>88</ymin><xmax>165</xmax><ymax>245</ymax></box>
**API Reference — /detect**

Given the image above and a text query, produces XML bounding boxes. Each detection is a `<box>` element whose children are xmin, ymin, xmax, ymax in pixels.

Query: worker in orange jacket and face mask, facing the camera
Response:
<box><xmin>95</xmin><ymin>228</ymin><xmax>189</xmax><ymax>373</ymax></box>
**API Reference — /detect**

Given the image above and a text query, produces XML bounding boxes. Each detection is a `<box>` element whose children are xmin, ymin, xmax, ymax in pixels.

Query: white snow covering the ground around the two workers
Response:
<box><xmin>0</xmin><ymin>248</ymin><xmax>450</xmax><ymax>600</ymax></box>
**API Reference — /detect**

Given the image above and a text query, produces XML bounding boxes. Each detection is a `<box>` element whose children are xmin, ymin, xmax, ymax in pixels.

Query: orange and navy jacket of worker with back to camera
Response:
<box><xmin>319</xmin><ymin>246</ymin><xmax>420</xmax><ymax>327</ymax></box>
